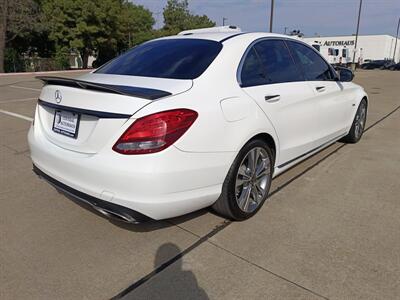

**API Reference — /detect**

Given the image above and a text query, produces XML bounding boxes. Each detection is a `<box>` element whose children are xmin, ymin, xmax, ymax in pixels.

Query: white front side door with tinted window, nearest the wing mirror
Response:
<box><xmin>287</xmin><ymin>41</ymin><xmax>351</xmax><ymax>146</ymax></box>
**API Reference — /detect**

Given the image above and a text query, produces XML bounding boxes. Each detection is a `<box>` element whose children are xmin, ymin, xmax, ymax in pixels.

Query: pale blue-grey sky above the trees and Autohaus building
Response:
<box><xmin>133</xmin><ymin>0</ymin><xmax>400</xmax><ymax>36</ymax></box>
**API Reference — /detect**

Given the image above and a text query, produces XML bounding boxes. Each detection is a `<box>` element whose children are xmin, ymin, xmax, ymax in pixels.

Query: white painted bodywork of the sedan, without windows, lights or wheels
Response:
<box><xmin>28</xmin><ymin>30</ymin><xmax>367</xmax><ymax>219</ymax></box>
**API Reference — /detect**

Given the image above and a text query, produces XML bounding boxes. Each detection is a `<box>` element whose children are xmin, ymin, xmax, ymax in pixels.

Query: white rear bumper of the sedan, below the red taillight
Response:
<box><xmin>28</xmin><ymin>124</ymin><xmax>236</xmax><ymax>221</ymax></box>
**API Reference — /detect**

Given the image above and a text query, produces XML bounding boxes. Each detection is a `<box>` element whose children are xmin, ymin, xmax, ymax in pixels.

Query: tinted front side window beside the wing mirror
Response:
<box><xmin>287</xmin><ymin>41</ymin><xmax>334</xmax><ymax>81</ymax></box>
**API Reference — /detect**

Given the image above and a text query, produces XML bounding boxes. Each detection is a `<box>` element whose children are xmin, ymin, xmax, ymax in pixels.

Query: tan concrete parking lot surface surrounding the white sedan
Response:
<box><xmin>0</xmin><ymin>71</ymin><xmax>400</xmax><ymax>299</ymax></box>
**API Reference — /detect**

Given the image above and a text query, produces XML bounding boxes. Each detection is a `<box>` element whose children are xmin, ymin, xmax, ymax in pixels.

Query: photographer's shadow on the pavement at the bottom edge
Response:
<box><xmin>119</xmin><ymin>243</ymin><xmax>209</xmax><ymax>300</ymax></box>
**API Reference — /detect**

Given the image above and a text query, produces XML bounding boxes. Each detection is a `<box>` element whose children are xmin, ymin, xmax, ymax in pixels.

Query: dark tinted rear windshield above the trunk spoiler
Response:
<box><xmin>96</xmin><ymin>39</ymin><xmax>222</xmax><ymax>79</ymax></box>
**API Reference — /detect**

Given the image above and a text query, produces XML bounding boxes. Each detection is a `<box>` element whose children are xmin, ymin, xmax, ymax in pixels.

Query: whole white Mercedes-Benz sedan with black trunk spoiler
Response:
<box><xmin>28</xmin><ymin>27</ymin><xmax>368</xmax><ymax>223</ymax></box>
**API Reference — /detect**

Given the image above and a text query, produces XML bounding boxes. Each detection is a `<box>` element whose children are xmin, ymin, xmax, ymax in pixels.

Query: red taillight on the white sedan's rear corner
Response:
<box><xmin>113</xmin><ymin>109</ymin><xmax>198</xmax><ymax>154</ymax></box>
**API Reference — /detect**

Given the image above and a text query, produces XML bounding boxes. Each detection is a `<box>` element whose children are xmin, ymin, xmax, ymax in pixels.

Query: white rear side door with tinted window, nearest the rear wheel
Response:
<box><xmin>238</xmin><ymin>39</ymin><xmax>317</xmax><ymax>167</ymax></box>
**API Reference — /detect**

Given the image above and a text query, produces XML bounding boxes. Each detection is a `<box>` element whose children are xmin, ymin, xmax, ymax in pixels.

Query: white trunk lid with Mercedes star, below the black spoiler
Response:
<box><xmin>35</xmin><ymin>85</ymin><xmax>151</xmax><ymax>153</ymax></box>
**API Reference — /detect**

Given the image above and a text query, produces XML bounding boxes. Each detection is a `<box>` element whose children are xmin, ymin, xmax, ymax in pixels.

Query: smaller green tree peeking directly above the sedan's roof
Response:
<box><xmin>163</xmin><ymin>0</ymin><xmax>215</xmax><ymax>34</ymax></box>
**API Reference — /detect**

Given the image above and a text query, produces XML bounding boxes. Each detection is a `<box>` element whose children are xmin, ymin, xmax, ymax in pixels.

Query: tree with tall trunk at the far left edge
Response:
<box><xmin>0</xmin><ymin>0</ymin><xmax>39</xmax><ymax>73</ymax></box>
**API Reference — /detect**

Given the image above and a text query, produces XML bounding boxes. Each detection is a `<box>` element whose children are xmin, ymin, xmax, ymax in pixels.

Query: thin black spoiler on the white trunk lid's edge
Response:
<box><xmin>36</xmin><ymin>76</ymin><xmax>172</xmax><ymax>100</ymax></box>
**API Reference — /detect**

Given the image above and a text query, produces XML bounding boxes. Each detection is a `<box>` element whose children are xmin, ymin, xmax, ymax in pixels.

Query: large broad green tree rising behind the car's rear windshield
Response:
<box><xmin>43</xmin><ymin>0</ymin><xmax>154</xmax><ymax>68</ymax></box>
